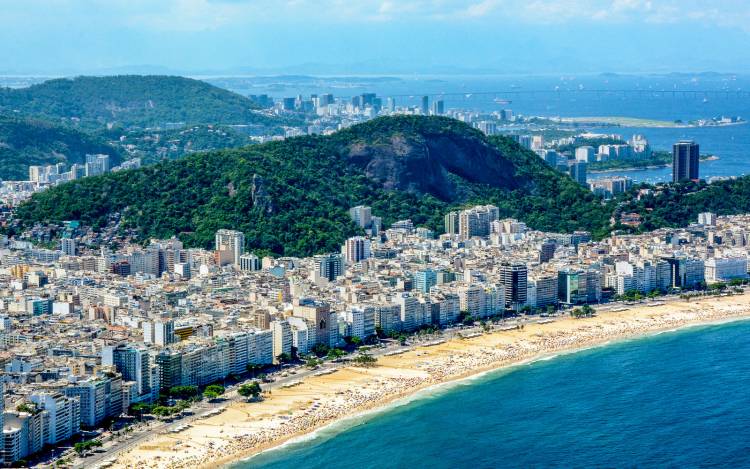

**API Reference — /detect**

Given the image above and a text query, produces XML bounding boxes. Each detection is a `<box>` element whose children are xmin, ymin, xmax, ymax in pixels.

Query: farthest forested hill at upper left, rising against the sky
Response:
<box><xmin>0</xmin><ymin>75</ymin><xmax>278</xmax><ymax>129</ymax></box>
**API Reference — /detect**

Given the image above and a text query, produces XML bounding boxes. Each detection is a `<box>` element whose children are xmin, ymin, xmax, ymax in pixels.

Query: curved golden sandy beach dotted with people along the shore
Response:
<box><xmin>107</xmin><ymin>295</ymin><xmax>750</xmax><ymax>468</ymax></box>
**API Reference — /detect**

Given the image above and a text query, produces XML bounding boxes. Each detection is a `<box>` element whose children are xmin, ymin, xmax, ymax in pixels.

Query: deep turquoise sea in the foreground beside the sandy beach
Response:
<box><xmin>235</xmin><ymin>321</ymin><xmax>750</xmax><ymax>469</ymax></box>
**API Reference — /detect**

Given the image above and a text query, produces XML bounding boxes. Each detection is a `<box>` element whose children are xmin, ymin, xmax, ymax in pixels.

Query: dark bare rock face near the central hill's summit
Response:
<box><xmin>345</xmin><ymin>134</ymin><xmax>528</xmax><ymax>201</ymax></box>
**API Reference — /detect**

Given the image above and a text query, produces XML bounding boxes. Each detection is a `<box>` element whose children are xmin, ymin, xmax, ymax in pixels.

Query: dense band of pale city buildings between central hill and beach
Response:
<box><xmin>0</xmin><ymin>206</ymin><xmax>750</xmax><ymax>462</ymax></box>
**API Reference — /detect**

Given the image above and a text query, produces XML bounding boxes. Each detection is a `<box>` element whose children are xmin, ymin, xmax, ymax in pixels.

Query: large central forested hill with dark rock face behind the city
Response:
<box><xmin>16</xmin><ymin>116</ymin><xmax>612</xmax><ymax>256</ymax></box>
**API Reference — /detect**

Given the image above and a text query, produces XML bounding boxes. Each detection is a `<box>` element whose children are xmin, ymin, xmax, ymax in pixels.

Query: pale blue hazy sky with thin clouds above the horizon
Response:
<box><xmin>0</xmin><ymin>0</ymin><xmax>750</xmax><ymax>75</ymax></box>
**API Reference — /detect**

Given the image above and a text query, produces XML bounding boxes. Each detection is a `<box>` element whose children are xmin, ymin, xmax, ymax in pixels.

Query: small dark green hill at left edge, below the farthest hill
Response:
<box><xmin>0</xmin><ymin>116</ymin><xmax>120</xmax><ymax>180</ymax></box>
